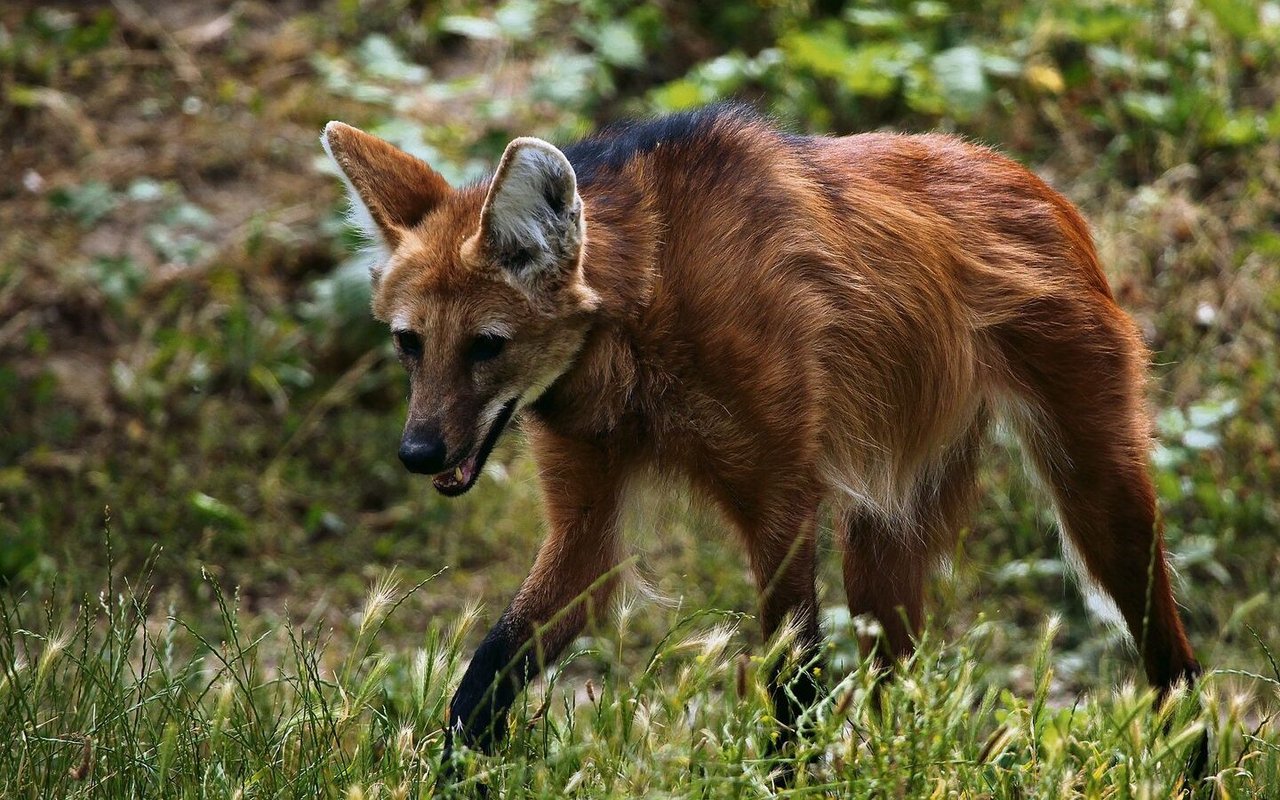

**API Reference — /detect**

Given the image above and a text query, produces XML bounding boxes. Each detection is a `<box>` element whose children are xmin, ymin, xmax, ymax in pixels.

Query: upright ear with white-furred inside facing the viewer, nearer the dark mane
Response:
<box><xmin>471</xmin><ymin>137</ymin><xmax>585</xmax><ymax>294</ymax></box>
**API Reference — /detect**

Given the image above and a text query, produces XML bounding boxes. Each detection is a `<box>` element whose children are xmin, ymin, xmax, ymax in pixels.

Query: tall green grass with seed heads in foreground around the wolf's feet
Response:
<box><xmin>0</xmin><ymin>532</ymin><xmax>1280</xmax><ymax>797</ymax></box>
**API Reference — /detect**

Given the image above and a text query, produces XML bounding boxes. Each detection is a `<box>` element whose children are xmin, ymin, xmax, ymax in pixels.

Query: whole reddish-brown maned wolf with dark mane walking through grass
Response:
<box><xmin>324</xmin><ymin>105</ymin><xmax>1199</xmax><ymax>762</ymax></box>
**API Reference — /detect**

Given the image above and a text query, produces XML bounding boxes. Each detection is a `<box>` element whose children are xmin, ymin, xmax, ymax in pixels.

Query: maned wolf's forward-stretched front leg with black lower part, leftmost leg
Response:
<box><xmin>445</xmin><ymin>433</ymin><xmax>621</xmax><ymax>756</ymax></box>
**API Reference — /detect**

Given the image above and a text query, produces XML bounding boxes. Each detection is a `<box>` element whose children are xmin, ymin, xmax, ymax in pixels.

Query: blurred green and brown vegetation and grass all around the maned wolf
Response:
<box><xmin>0</xmin><ymin>0</ymin><xmax>1280</xmax><ymax>797</ymax></box>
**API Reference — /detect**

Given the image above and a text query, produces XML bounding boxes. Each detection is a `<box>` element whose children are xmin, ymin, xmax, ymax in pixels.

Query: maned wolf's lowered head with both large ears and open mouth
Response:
<box><xmin>321</xmin><ymin>122</ymin><xmax>598</xmax><ymax>495</ymax></box>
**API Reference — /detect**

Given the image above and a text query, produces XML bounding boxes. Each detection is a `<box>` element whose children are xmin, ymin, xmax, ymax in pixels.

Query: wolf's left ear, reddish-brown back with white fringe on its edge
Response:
<box><xmin>320</xmin><ymin>122</ymin><xmax>451</xmax><ymax>256</ymax></box>
